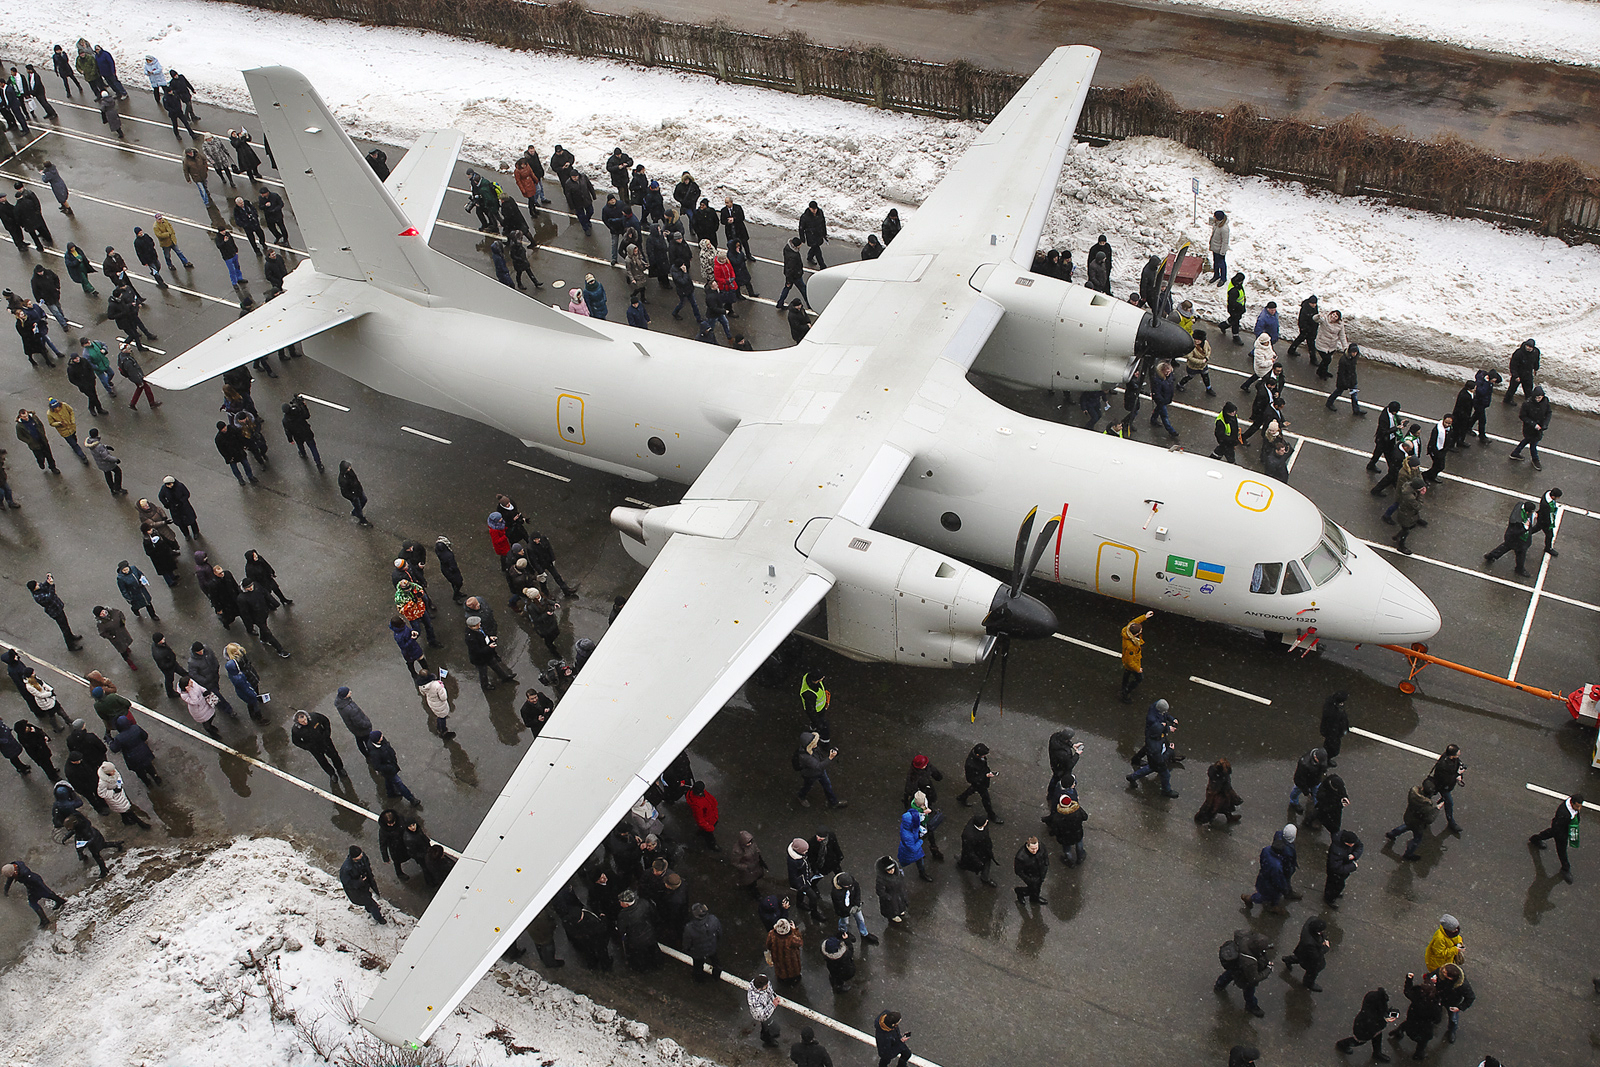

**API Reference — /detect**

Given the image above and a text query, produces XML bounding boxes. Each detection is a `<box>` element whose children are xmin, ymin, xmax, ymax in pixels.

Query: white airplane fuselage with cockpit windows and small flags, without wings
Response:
<box><xmin>297</xmin><ymin>271</ymin><xmax>1438</xmax><ymax>643</ymax></box>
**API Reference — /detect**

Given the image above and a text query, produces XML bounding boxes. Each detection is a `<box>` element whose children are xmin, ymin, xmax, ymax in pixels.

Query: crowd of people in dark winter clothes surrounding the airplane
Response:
<box><xmin>0</xmin><ymin>42</ymin><xmax>1582</xmax><ymax>1067</ymax></box>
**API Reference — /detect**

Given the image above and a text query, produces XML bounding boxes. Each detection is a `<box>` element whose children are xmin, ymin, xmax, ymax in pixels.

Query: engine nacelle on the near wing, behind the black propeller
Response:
<box><xmin>802</xmin><ymin>518</ymin><xmax>1006</xmax><ymax>667</ymax></box>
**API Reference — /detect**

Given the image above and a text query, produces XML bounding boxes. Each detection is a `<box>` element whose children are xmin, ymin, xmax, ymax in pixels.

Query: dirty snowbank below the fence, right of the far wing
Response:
<box><xmin>1045</xmin><ymin>136</ymin><xmax>1600</xmax><ymax>411</ymax></box>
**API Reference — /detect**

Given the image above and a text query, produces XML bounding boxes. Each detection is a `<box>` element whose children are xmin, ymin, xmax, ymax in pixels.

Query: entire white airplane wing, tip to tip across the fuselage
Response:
<box><xmin>360</xmin><ymin>50</ymin><xmax>1098</xmax><ymax>1045</ymax></box>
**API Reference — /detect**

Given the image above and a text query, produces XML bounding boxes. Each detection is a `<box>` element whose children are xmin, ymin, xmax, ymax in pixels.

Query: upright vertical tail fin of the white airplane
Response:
<box><xmin>245</xmin><ymin>67</ymin><xmax>429</xmax><ymax>293</ymax></box>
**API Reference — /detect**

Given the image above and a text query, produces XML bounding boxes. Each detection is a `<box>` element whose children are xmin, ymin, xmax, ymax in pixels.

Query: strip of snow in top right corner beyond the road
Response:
<box><xmin>1162</xmin><ymin>0</ymin><xmax>1600</xmax><ymax>67</ymax></box>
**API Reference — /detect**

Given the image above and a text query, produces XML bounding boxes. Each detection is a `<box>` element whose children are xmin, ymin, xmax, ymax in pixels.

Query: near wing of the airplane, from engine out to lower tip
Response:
<box><xmin>362</xmin><ymin>534</ymin><xmax>832</xmax><ymax>1045</ymax></box>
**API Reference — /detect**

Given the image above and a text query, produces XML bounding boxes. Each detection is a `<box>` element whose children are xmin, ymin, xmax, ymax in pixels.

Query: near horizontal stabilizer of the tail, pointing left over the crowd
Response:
<box><xmin>147</xmin><ymin>267</ymin><xmax>371</xmax><ymax>389</ymax></box>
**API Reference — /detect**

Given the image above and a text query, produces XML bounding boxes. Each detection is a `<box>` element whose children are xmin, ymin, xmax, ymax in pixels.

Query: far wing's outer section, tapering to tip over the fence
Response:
<box><xmin>882</xmin><ymin>45</ymin><xmax>1099</xmax><ymax>267</ymax></box>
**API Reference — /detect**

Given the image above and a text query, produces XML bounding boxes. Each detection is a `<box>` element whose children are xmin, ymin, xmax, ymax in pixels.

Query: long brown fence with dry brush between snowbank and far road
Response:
<box><xmin>228</xmin><ymin>0</ymin><xmax>1600</xmax><ymax>243</ymax></box>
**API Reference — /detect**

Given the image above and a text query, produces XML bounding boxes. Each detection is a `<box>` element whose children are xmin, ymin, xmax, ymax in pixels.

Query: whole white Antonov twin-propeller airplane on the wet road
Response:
<box><xmin>150</xmin><ymin>46</ymin><xmax>1440</xmax><ymax>1045</ymax></box>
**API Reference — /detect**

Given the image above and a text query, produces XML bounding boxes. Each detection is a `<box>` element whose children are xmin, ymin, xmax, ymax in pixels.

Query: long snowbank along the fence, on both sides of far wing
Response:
<box><xmin>0</xmin><ymin>0</ymin><xmax>1600</xmax><ymax>410</ymax></box>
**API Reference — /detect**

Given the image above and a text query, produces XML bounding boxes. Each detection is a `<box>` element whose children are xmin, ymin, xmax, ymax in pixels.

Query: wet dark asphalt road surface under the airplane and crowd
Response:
<box><xmin>0</xmin><ymin>94</ymin><xmax>1600</xmax><ymax>1065</ymax></box>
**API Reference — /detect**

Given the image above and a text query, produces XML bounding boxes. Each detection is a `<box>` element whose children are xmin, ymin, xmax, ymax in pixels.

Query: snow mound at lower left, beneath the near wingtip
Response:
<box><xmin>0</xmin><ymin>838</ymin><xmax>712</xmax><ymax>1067</ymax></box>
